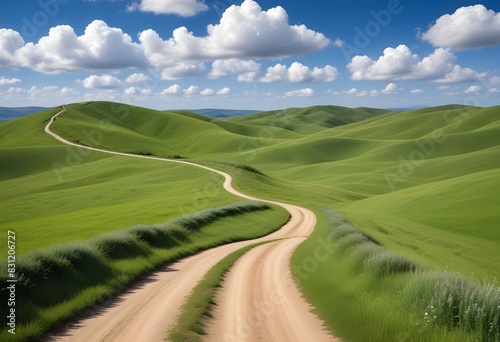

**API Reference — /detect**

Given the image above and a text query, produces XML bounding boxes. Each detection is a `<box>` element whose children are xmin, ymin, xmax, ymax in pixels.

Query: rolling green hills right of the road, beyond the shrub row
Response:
<box><xmin>33</xmin><ymin>102</ymin><xmax>500</xmax><ymax>276</ymax></box>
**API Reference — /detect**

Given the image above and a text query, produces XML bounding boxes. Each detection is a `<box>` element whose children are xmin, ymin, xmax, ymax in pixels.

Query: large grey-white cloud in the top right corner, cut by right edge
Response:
<box><xmin>420</xmin><ymin>5</ymin><xmax>500</xmax><ymax>50</ymax></box>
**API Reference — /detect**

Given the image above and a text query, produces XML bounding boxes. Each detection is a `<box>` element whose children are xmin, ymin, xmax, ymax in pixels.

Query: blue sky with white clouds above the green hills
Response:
<box><xmin>0</xmin><ymin>0</ymin><xmax>500</xmax><ymax>110</ymax></box>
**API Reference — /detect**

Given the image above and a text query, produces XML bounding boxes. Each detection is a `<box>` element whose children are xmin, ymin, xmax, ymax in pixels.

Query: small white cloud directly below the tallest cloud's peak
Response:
<box><xmin>208</xmin><ymin>58</ymin><xmax>260</xmax><ymax>82</ymax></box>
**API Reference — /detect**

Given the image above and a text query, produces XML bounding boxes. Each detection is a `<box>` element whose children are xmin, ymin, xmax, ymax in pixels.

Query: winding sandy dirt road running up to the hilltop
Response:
<box><xmin>45</xmin><ymin>107</ymin><xmax>336</xmax><ymax>342</ymax></box>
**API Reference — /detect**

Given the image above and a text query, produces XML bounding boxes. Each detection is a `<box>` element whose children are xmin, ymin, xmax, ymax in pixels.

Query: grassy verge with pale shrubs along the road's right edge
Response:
<box><xmin>292</xmin><ymin>209</ymin><xmax>500</xmax><ymax>342</ymax></box>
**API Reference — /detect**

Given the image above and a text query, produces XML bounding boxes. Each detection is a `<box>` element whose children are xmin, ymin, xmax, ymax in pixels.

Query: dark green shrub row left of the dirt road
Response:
<box><xmin>0</xmin><ymin>201</ymin><xmax>271</xmax><ymax>327</ymax></box>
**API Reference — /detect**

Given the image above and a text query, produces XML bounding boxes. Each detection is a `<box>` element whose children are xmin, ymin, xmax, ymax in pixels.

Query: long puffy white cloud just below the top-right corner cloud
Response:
<box><xmin>347</xmin><ymin>45</ymin><xmax>486</xmax><ymax>83</ymax></box>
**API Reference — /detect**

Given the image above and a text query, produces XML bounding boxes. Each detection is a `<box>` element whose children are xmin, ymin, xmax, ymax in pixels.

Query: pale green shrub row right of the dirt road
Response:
<box><xmin>322</xmin><ymin>209</ymin><xmax>500</xmax><ymax>342</ymax></box>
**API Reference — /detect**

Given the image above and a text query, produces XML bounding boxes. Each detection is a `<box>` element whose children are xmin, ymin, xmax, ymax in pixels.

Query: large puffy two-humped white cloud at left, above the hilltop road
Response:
<box><xmin>15</xmin><ymin>20</ymin><xmax>147</xmax><ymax>74</ymax></box>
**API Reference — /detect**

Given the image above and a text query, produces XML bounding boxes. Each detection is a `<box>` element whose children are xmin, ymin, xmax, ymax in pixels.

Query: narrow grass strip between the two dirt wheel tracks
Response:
<box><xmin>167</xmin><ymin>240</ymin><xmax>274</xmax><ymax>342</ymax></box>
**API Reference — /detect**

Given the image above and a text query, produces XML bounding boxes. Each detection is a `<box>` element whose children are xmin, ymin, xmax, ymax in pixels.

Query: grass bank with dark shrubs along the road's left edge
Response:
<box><xmin>0</xmin><ymin>202</ymin><xmax>289</xmax><ymax>341</ymax></box>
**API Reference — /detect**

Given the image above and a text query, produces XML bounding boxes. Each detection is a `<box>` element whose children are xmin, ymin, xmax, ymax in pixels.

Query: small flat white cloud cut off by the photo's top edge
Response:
<box><xmin>127</xmin><ymin>0</ymin><xmax>208</xmax><ymax>17</ymax></box>
